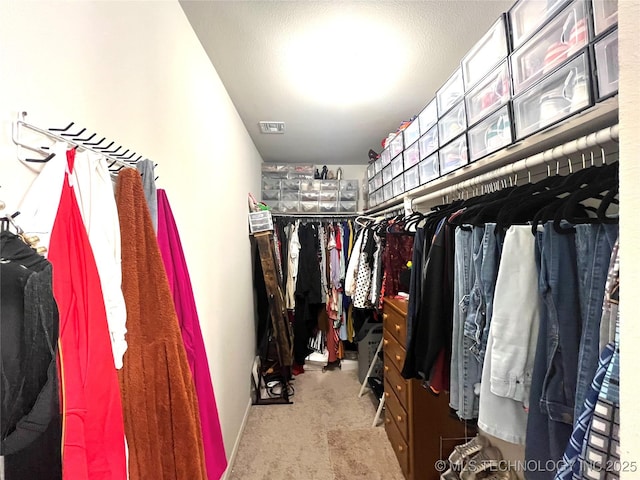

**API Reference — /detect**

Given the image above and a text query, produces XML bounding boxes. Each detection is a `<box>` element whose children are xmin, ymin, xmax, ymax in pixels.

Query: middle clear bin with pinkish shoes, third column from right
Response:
<box><xmin>465</xmin><ymin>61</ymin><xmax>511</xmax><ymax>125</ymax></box>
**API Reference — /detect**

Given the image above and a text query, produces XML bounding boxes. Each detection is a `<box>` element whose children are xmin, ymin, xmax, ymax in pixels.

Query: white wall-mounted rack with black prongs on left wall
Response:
<box><xmin>11</xmin><ymin>112</ymin><xmax>152</xmax><ymax>172</ymax></box>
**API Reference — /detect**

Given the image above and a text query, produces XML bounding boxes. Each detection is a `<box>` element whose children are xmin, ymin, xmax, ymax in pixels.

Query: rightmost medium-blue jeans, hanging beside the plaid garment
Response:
<box><xmin>574</xmin><ymin>224</ymin><xmax>618</xmax><ymax>419</ymax></box>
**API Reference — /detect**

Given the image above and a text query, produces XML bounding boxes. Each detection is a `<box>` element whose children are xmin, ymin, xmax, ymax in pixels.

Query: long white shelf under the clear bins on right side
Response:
<box><xmin>364</xmin><ymin>95</ymin><xmax>618</xmax><ymax>215</ymax></box>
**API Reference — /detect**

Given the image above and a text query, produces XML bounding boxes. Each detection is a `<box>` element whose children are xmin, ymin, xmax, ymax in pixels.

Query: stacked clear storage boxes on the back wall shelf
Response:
<box><xmin>262</xmin><ymin>163</ymin><xmax>359</xmax><ymax>213</ymax></box>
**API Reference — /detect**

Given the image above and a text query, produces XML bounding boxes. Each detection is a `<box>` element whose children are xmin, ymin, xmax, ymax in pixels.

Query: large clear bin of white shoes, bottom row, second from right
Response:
<box><xmin>513</xmin><ymin>51</ymin><xmax>592</xmax><ymax>139</ymax></box>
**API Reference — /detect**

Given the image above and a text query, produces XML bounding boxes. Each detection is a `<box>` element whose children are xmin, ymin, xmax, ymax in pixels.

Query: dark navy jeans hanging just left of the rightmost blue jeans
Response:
<box><xmin>525</xmin><ymin>223</ymin><xmax>582</xmax><ymax>480</ymax></box>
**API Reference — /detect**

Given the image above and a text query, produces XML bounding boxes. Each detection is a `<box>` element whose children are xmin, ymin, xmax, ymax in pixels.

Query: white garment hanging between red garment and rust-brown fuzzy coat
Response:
<box><xmin>72</xmin><ymin>151</ymin><xmax>127</xmax><ymax>369</ymax></box>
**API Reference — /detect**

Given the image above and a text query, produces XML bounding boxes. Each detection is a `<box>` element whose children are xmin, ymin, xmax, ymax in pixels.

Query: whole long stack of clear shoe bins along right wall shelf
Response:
<box><xmin>367</xmin><ymin>0</ymin><xmax>618</xmax><ymax>207</ymax></box>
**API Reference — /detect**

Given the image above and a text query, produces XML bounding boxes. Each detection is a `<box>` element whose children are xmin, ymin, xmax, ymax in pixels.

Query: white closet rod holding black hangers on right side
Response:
<box><xmin>372</xmin><ymin>124</ymin><xmax>619</xmax><ymax>216</ymax></box>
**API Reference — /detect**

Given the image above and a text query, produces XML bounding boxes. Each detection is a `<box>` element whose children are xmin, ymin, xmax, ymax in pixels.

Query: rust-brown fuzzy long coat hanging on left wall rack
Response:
<box><xmin>116</xmin><ymin>168</ymin><xmax>207</xmax><ymax>480</ymax></box>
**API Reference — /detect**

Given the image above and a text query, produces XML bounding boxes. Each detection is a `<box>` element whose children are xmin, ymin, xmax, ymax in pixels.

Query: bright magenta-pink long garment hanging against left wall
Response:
<box><xmin>158</xmin><ymin>189</ymin><xmax>227</xmax><ymax>480</ymax></box>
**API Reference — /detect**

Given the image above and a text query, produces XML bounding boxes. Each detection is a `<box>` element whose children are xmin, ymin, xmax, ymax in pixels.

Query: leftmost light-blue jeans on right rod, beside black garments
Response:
<box><xmin>450</xmin><ymin>227</ymin><xmax>482</xmax><ymax>420</ymax></box>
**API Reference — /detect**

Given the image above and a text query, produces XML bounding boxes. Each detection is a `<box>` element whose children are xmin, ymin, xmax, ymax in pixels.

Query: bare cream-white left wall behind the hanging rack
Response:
<box><xmin>0</xmin><ymin>0</ymin><xmax>262</xmax><ymax>464</ymax></box>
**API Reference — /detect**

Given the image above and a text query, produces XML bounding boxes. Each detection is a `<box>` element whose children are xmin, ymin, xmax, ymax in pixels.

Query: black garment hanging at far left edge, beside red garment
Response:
<box><xmin>0</xmin><ymin>232</ymin><xmax>62</xmax><ymax>480</ymax></box>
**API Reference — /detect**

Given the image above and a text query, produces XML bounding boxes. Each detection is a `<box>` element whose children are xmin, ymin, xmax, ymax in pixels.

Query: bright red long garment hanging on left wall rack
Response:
<box><xmin>48</xmin><ymin>150</ymin><xmax>127</xmax><ymax>480</ymax></box>
